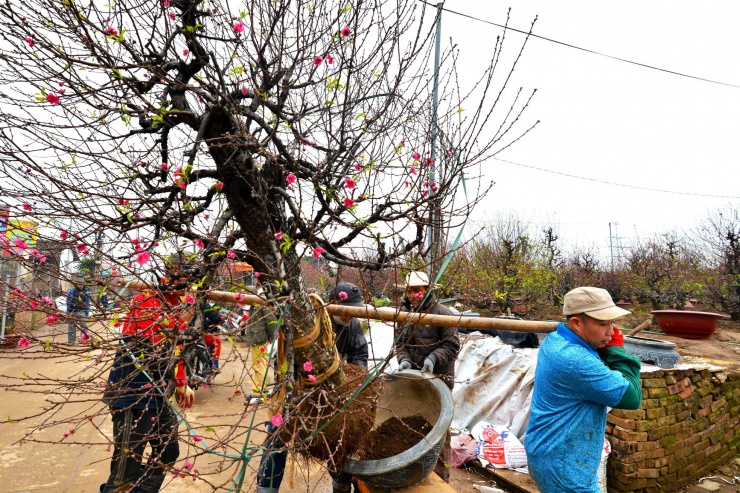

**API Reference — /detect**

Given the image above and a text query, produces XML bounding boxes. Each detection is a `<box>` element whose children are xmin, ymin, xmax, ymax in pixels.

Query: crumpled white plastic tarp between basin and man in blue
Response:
<box><xmin>452</xmin><ymin>333</ymin><xmax>538</xmax><ymax>439</ymax></box>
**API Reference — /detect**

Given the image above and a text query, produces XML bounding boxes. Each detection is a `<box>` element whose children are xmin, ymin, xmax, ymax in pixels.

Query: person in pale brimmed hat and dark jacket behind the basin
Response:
<box><xmin>395</xmin><ymin>271</ymin><xmax>460</xmax><ymax>482</ymax></box>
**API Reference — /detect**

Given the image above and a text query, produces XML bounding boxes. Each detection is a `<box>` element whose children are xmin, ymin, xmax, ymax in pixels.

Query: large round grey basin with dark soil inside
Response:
<box><xmin>344</xmin><ymin>370</ymin><xmax>453</xmax><ymax>491</ymax></box>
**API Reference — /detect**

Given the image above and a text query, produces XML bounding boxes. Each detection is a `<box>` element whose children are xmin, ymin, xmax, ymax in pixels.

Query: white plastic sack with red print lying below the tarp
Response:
<box><xmin>471</xmin><ymin>421</ymin><xmax>527</xmax><ymax>469</ymax></box>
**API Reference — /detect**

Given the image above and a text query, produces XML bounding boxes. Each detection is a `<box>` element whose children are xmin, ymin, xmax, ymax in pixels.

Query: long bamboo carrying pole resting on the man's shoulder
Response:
<box><xmin>111</xmin><ymin>280</ymin><xmax>558</xmax><ymax>333</ymax></box>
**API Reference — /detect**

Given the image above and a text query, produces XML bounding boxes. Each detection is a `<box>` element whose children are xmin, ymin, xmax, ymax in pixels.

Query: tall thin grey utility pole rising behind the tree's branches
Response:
<box><xmin>427</xmin><ymin>2</ymin><xmax>444</xmax><ymax>279</ymax></box>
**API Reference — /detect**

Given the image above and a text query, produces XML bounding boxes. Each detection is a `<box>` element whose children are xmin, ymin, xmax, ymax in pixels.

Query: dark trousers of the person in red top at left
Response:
<box><xmin>100</xmin><ymin>406</ymin><xmax>180</xmax><ymax>493</ymax></box>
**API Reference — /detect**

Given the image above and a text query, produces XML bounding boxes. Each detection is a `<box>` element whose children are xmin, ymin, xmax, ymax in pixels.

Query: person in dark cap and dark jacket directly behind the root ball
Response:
<box><xmin>257</xmin><ymin>282</ymin><xmax>368</xmax><ymax>493</ymax></box>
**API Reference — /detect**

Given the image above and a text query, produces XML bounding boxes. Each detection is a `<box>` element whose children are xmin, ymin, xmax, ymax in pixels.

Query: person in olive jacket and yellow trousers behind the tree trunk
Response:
<box><xmin>245</xmin><ymin>285</ymin><xmax>277</xmax><ymax>404</ymax></box>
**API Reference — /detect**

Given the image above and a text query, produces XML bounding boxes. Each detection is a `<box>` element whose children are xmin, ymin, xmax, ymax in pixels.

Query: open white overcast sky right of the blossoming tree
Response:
<box><xmin>434</xmin><ymin>0</ymin><xmax>740</xmax><ymax>255</ymax></box>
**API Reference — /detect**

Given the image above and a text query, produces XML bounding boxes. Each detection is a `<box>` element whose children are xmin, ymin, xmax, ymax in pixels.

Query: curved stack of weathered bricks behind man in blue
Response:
<box><xmin>606</xmin><ymin>365</ymin><xmax>740</xmax><ymax>493</ymax></box>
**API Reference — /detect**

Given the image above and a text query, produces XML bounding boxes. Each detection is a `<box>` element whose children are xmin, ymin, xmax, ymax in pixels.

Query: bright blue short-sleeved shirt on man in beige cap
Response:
<box><xmin>524</xmin><ymin>324</ymin><xmax>629</xmax><ymax>493</ymax></box>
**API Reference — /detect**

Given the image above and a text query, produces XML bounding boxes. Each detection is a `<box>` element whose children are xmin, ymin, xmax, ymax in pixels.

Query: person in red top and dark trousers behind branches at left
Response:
<box><xmin>100</xmin><ymin>268</ymin><xmax>195</xmax><ymax>493</ymax></box>
